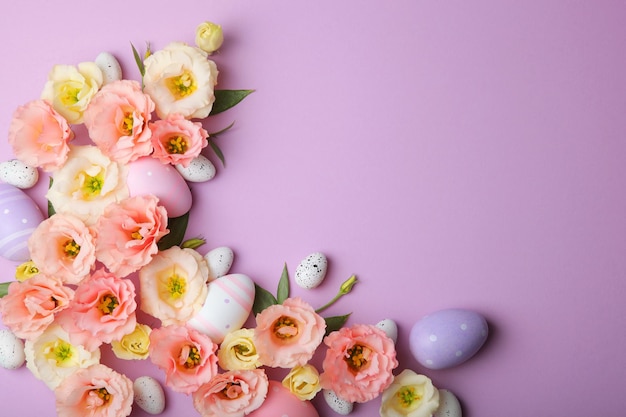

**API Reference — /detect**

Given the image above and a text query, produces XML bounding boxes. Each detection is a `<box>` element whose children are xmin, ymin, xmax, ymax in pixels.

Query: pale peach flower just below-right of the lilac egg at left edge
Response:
<box><xmin>28</xmin><ymin>213</ymin><xmax>96</xmax><ymax>284</ymax></box>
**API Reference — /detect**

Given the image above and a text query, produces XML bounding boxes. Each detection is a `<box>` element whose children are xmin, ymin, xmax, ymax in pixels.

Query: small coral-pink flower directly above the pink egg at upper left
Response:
<box><xmin>150</xmin><ymin>113</ymin><xmax>209</xmax><ymax>167</ymax></box>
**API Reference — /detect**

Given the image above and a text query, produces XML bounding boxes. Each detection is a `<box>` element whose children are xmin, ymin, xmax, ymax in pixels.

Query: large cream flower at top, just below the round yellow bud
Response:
<box><xmin>143</xmin><ymin>42</ymin><xmax>218</xmax><ymax>119</ymax></box>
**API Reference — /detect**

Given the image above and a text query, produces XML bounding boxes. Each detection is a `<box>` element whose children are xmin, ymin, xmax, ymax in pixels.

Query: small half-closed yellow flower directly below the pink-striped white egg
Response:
<box><xmin>217</xmin><ymin>329</ymin><xmax>261</xmax><ymax>371</ymax></box>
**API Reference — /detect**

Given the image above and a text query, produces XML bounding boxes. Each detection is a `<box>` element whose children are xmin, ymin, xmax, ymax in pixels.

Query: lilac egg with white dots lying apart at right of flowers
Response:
<box><xmin>409</xmin><ymin>309</ymin><xmax>489</xmax><ymax>369</ymax></box>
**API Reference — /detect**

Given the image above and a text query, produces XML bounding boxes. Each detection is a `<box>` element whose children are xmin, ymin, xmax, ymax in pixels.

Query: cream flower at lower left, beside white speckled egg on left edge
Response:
<box><xmin>24</xmin><ymin>324</ymin><xmax>100</xmax><ymax>390</ymax></box>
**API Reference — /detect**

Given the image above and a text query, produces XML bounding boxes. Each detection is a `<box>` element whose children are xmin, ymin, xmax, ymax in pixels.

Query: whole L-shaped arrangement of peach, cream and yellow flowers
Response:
<box><xmin>0</xmin><ymin>24</ymin><xmax>438</xmax><ymax>417</ymax></box>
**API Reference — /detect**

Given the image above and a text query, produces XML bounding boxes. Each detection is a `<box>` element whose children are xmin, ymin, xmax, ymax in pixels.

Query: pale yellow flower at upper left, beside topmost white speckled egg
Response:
<box><xmin>41</xmin><ymin>62</ymin><xmax>104</xmax><ymax>123</ymax></box>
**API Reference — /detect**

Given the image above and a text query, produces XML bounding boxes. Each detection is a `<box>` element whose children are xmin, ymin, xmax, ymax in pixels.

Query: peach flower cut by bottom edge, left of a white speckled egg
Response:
<box><xmin>54</xmin><ymin>364</ymin><xmax>134</xmax><ymax>417</ymax></box>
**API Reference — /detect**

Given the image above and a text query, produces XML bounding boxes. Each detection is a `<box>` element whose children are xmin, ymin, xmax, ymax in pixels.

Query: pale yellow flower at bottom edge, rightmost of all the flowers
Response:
<box><xmin>380</xmin><ymin>369</ymin><xmax>439</xmax><ymax>417</ymax></box>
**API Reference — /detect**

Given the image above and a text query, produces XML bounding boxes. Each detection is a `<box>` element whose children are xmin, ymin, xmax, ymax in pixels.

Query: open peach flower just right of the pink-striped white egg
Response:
<box><xmin>254</xmin><ymin>297</ymin><xmax>326</xmax><ymax>368</ymax></box>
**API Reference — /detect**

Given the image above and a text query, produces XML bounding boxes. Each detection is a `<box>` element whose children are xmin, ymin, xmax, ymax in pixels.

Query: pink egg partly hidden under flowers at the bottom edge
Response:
<box><xmin>248</xmin><ymin>381</ymin><xmax>319</xmax><ymax>417</ymax></box>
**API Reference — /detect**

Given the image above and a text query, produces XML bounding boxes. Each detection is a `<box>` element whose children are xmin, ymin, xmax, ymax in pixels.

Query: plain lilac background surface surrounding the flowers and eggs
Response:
<box><xmin>0</xmin><ymin>0</ymin><xmax>626</xmax><ymax>417</ymax></box>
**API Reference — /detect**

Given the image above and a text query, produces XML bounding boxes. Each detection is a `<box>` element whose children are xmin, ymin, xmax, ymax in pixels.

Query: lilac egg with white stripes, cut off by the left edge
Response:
<box><xmin>0</xmin><ymin>183</ymin><xmax>44</xmax><ymax>262</ymax></box>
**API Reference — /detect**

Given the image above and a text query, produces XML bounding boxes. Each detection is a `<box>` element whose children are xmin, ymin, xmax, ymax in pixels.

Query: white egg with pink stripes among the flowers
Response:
<box><xmin>187</xmin><ymin>274</ymin><xmax>254</xmax><ymax>344</ymax></box>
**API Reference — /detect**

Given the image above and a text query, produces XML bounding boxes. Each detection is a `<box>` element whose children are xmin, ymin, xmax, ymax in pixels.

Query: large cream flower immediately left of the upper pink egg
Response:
<box><xmin>46</xmin><ymin>145</ymin><xmax>129</xmax><ymax>226</ymax></box>
